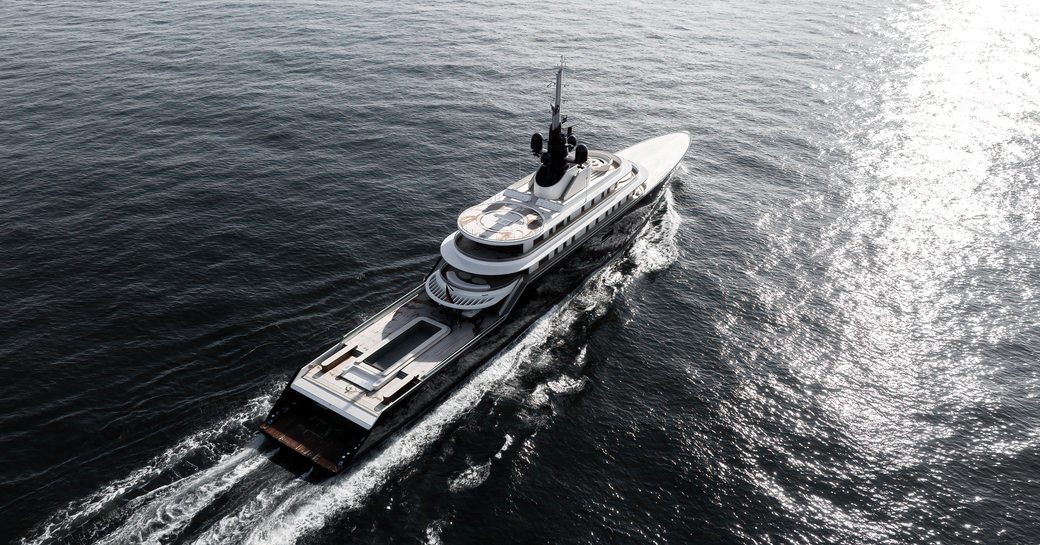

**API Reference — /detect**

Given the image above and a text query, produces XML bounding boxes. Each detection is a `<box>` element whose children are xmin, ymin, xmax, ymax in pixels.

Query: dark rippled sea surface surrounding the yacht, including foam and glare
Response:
<box><xmin>0</xmin><ymin>0</ymin><xmax>1040</xmax><ymax>544</ymax></box>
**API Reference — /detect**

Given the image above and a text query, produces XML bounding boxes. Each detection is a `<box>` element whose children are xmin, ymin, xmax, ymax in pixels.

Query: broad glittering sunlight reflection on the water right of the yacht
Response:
<box><xmin>717</xmin><ymin>0</ymin><xmax>1040</xmax><ymax>539</ymax></box>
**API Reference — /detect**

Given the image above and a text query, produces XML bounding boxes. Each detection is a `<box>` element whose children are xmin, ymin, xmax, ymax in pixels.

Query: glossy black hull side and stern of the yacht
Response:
<box><xmin>261</xmin><ymin>183</ymin><xmax>665</xmax><ymax>473</ymax></box>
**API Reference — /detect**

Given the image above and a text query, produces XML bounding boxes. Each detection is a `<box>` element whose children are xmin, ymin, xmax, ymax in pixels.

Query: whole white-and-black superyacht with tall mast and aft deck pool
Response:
<box><xmin>260</xmin><ymin>64</ymin><xmax>690</xmax><ymax>473</ymax></box>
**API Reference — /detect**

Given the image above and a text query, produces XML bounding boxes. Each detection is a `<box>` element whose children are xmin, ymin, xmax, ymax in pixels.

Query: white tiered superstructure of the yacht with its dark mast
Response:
<box><xmin>425</xmin><ymin>67</ymin><xmax>690</xmax><ymax>311</ymax></box>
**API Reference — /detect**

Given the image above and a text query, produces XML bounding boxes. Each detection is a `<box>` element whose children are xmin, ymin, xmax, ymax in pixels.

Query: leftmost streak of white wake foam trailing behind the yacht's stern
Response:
<box><xmin>20</xmin><ymin>392</ymin><xmax>272</xmax><ymax>545</ymax></box>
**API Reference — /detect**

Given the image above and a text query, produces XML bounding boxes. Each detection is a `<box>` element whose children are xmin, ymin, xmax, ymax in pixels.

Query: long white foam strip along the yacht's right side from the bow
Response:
<box><xmin>205</xmin><ymin>188</ymin><xmax>681</xmax><ymax>545</ymax></box>
